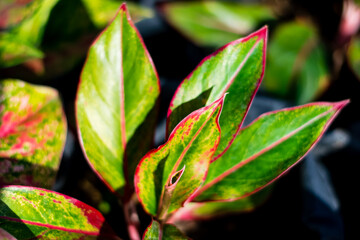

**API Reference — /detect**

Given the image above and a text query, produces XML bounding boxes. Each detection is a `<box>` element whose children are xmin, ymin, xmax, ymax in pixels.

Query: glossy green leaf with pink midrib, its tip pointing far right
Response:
<box><xmin>195</xmin><ymin>101</ymin><xmax>348</xmax><ymax>201</ymax></box>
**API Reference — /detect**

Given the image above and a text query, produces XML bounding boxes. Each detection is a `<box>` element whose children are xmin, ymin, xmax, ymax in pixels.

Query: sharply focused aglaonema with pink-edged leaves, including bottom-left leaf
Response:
<box><xmin>0</xmin><ymin>4</ymin><xmax>348</xmax><ymax>239</ymax></box>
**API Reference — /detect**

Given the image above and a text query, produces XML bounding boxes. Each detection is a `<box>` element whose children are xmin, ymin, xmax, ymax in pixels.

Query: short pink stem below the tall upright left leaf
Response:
<box><xmin>124</xmin><ymin>199</ymin><xmax>141</xmax><ymax>240</ymax></box>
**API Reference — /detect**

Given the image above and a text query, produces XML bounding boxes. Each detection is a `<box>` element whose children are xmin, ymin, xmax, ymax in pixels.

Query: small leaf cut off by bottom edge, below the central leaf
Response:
<box><xmin>143</xmin><ymin>220</ymin><xmax>189</xmax><ymax>240</ymax></box>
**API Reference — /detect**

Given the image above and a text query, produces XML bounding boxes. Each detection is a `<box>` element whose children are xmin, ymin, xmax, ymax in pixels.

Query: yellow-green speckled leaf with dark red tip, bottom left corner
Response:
<box><xmin>0</xmin><ymin>186</ymin><xmax>115</xmax><ymax>239</ymax></box>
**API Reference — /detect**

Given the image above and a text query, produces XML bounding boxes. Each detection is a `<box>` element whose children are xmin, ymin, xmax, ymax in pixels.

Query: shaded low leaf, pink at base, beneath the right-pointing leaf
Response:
<box><xmin>169</xmin><ymin>187</ymin><xmax>272</xmax><ymax>223</ymax></box>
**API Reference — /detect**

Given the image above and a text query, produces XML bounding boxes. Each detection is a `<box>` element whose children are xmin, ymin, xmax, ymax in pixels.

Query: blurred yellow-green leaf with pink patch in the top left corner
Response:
<box><xmin>0</xmin><ymin>0</ymin><xmax>59</xmax><ymax>67</ymax></box>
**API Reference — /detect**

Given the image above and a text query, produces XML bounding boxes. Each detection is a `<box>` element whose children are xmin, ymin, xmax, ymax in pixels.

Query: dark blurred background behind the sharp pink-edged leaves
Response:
<box><xmin>0</xmin><ymin>0</ymin><xmax>360</xmax><ymax>239</ymax></box>
